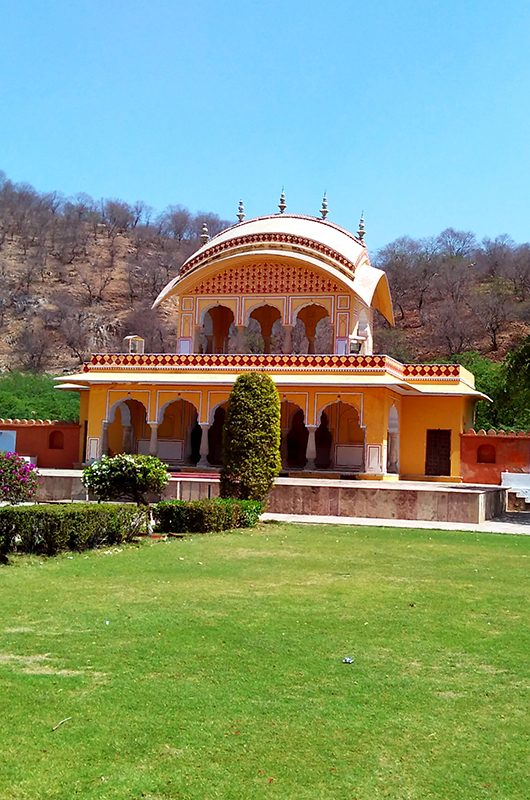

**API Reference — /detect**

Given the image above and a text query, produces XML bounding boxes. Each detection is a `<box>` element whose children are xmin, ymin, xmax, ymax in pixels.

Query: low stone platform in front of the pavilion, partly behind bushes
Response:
<box><xmin>38</xmin><ymin>469</ymin><xmax>506</xmax><ymax>523</ymax></box>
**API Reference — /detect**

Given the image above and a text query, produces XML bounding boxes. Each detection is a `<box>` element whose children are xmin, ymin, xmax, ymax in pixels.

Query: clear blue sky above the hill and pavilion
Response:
<box><xmin>0</xmin><ymin>0</ymin><xmax>530</xmax><ymax>250</ymax></box>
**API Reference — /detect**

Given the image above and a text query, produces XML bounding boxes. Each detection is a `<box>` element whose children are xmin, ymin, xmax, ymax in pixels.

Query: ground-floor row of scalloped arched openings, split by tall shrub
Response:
<box><xmin>102</xmin><ymin>397</ymin><xmax>378</xmax><ymax>472</ymax></box>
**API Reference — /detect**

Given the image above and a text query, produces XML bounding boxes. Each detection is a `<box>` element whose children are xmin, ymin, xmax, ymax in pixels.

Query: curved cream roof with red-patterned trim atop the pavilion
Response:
<box><xmin>153</xmin><ymin>214</ymin><xmax>394</xmax><ymax>323</ymax></box>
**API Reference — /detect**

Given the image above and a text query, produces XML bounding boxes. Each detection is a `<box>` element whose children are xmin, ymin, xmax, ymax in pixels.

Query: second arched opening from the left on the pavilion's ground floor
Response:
<box><xmin>156</xmin><ymin>398</ymin><xmax>201</xmax><ymax>465</ymax></box>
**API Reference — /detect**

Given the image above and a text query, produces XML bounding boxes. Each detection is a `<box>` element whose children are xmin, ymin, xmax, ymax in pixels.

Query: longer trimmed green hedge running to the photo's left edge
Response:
<box><xmin>0</xmin><ymin>503</ymin><xmax>146</xmax><ymax>557</ymax></box>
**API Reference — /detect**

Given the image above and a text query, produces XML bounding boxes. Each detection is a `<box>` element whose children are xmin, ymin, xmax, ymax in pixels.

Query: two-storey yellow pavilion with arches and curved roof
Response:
<box><xmin>59</xmin><ymin>203</ymin><xmax>482</xmax><ymax>481</ymax></box>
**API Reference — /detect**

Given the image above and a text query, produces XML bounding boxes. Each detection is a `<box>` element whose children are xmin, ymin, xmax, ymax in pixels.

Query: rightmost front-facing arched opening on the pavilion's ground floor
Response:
<box><xmin>315</xmin><ymin>400</ymin><xmax>364</xmax><ymax>472</ymax></box>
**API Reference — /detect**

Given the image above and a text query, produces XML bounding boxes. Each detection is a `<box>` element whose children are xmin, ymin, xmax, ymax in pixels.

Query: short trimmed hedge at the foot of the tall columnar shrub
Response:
<box><xmin>153</xmin><ymin>497</ymin><xmax>263</xmax><ymax>533</ymax></box>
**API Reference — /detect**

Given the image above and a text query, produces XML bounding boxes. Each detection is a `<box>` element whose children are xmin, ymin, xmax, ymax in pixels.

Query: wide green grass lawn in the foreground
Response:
<box><xmin>0</xmin><ymin>524</ymin><xmax>530</xmax><ymax>800</ymax></box>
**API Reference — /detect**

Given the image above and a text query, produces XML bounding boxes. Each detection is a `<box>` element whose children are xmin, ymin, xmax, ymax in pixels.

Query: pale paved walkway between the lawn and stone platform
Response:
<box><xmin>261</xmin><ymin>513</ymin><xmax>530</xmax><ymax>536</ymax></box>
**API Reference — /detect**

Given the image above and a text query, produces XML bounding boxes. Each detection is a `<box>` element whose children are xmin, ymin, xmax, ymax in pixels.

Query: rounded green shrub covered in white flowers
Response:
<box><xmin>83</xmin><ymin>453</ymin><xmax>169</xmax><ymax>505</ymax></box>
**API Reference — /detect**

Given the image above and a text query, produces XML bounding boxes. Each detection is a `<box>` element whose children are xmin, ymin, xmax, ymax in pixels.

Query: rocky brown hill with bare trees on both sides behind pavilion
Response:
<box><xmin>0</xmin><ymin>175</ymin><xmax>530</xmax><ymax>372</ymax></box>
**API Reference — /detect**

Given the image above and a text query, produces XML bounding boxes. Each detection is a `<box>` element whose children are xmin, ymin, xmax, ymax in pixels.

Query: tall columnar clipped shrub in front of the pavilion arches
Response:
<box><xmin>221</xmin><ymin>372</ymin><xmax>282</xmax><ymax>501</ymax></box>
